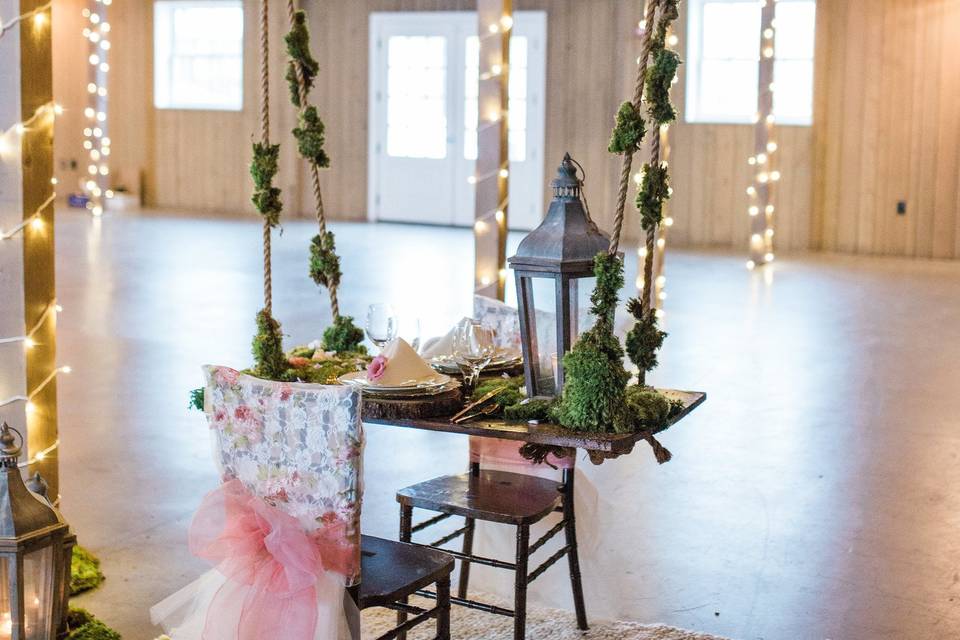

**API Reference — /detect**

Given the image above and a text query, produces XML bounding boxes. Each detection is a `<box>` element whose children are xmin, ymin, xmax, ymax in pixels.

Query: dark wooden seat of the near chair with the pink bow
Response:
<box><xmin>360</xmin><ymin>536</ymin><xmax>453</xmax><ymax>609</ymax></box>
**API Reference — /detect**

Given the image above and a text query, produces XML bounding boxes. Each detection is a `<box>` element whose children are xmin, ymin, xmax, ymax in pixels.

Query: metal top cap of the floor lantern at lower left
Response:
<box><xmin>0</xmin><ymin>422</ymin><xmax>67</xmax><ymax>552</ymax></box>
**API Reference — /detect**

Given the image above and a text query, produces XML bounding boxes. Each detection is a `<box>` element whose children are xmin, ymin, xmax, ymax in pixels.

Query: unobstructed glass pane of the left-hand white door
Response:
<box><xmin>387</xmin><ymin>36</ymin><xmax>447</xmax><ymax>159</ymax></box>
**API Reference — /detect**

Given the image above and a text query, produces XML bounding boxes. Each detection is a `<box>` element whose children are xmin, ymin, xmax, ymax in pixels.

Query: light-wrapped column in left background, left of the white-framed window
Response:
<box><xmin>82</xmin><ymin>0</ymin><xmax>113</xmax><ymax>216</ymax></box>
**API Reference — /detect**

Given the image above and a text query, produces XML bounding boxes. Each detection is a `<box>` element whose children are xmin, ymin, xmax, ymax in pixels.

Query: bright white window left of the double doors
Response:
<box><xmin>153</xmin><ymin>0</ymin><xmax>243</xmax><ymax>111</ymax></box>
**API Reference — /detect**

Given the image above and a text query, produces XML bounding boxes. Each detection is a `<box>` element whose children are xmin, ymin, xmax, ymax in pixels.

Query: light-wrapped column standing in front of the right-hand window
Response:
<box><xmin>747</xmin><ymin>0</ymin><xmax>781</xmax><ymax>269</ymax></box>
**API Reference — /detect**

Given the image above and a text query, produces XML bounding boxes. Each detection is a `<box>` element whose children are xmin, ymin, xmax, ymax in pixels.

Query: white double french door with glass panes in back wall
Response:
<box><xmin>367</xmin><ymin>11</ymin><xmax>547</xmax><ymax>229</ymax></box>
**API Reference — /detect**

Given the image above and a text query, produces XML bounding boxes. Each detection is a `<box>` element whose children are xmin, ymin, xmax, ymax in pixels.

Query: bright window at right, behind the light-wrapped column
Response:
<box><xmin>686</xmin><ymin>0</ymin><xmax>816</xmax><ymax>125</ymax></box>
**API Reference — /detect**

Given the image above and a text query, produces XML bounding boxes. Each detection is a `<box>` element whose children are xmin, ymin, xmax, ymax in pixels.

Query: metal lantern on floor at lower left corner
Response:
<box><xmin>0</xmin><ymin>423</ymin><xmax>72</xmax><ymax>640</ymax></box>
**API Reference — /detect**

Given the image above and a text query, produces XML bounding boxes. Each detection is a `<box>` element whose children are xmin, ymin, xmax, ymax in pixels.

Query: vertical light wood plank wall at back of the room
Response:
<box><xmin>55</xmin><ymin>0</ymin><xmax>960</xmax><ymax>257</ymax></box>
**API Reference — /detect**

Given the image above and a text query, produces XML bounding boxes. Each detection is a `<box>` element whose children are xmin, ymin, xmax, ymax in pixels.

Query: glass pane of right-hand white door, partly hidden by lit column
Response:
<box><xmin>463</xmin><ymin>36</ymin><xmax>529</xmax><ymax>162</ymax></box>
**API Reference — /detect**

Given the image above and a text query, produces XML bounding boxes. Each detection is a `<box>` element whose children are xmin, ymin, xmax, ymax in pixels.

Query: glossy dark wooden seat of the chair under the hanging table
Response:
<box><xmin>397</xmin><ymin>471</ymin><xmax>562</xmax><ymax>525</ymax></box>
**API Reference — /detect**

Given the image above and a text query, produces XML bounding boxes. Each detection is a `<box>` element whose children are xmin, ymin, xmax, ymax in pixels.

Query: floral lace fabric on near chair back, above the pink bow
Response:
<box><xmin>204</xmin><ymin>366</ymin><xmax>364</xmax><ymax>586</ymax></box>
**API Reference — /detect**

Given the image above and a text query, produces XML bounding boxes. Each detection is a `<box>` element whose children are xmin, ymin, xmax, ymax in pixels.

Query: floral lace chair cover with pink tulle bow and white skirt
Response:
<box><xmin>150</xmin><ymin>366</ymin><xmax>364</xmax><ymax>640</ymax></box>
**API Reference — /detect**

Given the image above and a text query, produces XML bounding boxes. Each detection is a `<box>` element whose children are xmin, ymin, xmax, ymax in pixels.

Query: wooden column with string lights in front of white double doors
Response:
<box><xmin>471</xmin><ymin>0</ymin><xmax>513</xmax><ymax>300</ymax></box>
